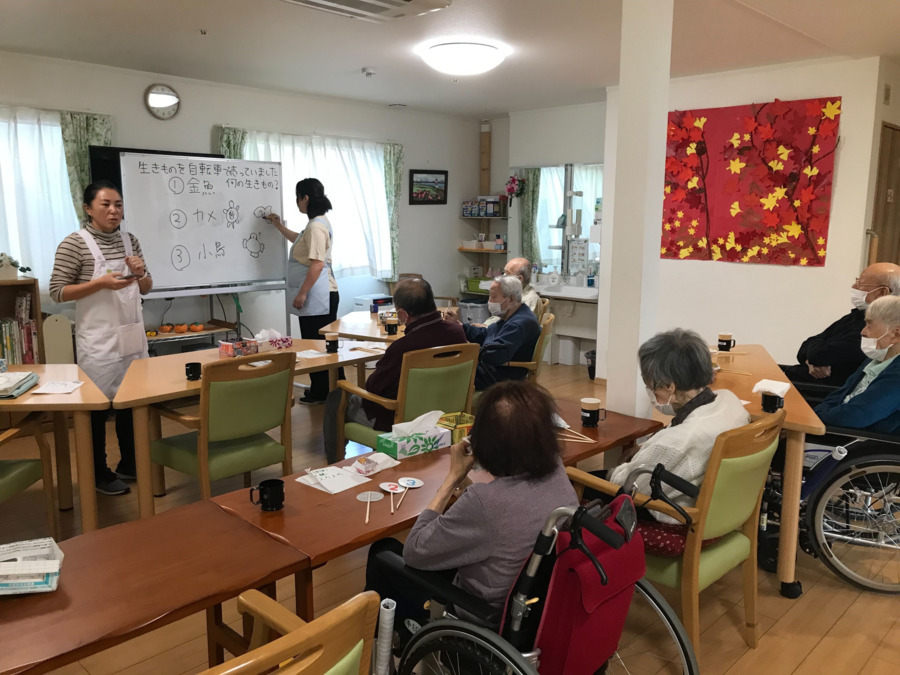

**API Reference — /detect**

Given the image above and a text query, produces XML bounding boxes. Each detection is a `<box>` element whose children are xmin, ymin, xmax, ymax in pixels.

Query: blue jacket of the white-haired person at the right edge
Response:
<box><xmin>815</xmin><ymin>357</ymin><xmax>900</xmax><ymax>434</ymax></box>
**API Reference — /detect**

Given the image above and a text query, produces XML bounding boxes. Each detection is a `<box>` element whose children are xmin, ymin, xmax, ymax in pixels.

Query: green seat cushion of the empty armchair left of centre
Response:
<box><xmin>150</xmin><ymin>431</ymin><xmax>284</xmax><ymax>481</ymax></box>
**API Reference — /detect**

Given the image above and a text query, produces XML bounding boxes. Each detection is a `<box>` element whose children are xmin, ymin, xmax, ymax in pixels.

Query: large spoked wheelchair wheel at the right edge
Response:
<box><xmin>806</xmin><ymin>455</ymin><xmax>900</xmax><ymax>593</ymax></box>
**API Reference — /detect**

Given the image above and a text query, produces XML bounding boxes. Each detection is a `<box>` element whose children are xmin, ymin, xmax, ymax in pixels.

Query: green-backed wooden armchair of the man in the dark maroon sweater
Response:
<box><xmin>337</xmin><ymin>343</ymin><xmax>479</xmax><ymax>459</ymax></box>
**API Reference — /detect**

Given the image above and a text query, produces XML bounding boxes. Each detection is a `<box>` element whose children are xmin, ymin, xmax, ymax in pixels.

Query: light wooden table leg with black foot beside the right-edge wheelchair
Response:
<box><xmin>778</xmin><ymin>431</ymin><xmax>806</xmax><ymax>598</ymax></box>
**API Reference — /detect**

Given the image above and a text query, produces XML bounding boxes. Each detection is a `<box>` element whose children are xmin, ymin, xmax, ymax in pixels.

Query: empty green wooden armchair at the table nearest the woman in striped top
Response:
<box><xmin>150</xmin><ymin>352</ymin><xmax>296</xmax><ymax>499</ymax></box>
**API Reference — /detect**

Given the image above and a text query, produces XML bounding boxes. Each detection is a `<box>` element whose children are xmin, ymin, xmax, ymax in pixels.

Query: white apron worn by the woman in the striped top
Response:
<box><xmin>75</xmin><ymin>229</ymin><xmax>149</xmax><ymax>400</ymax></box>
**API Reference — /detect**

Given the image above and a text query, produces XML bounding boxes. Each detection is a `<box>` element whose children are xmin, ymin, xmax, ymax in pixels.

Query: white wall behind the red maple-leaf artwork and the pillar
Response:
<box><xmin>597</xmin><ymin>58</ymin><xmax>880</xmax><ymax>377</ymax></box>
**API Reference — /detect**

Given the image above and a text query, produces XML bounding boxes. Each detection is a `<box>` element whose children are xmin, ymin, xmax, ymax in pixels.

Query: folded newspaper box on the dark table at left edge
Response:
<box><xmin>0</xmin><ymin>537</ymin><xmax>63</xmax><ymax>595</ymax></box>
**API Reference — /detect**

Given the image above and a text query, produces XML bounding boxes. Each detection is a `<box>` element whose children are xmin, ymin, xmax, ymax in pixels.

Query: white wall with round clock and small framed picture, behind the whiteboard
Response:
<box><xmin>0</xmin><ymin>52</ymin><xmax>480</xmax><ymax>330</ymax></box>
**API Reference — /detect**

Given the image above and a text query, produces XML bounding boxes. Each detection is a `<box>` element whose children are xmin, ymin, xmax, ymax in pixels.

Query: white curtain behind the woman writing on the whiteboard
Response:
<box><xmin>243</xmin><ymin>131</ymin><xmax>393</xmax><ymax>279</ymax></box>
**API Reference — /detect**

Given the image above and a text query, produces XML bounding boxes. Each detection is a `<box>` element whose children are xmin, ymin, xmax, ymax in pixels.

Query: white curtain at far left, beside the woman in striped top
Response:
<box><xmin>0</xmin><ymin>106</ymin><xmax>79</xmax><ymax>289</ymax></box>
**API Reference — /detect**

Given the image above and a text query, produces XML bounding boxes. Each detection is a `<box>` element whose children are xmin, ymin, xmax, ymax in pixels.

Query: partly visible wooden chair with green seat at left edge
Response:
<box><xmin>0</xmin><ymin>412</ymin><xmax>59</xmax><ymax>540</ymax></box>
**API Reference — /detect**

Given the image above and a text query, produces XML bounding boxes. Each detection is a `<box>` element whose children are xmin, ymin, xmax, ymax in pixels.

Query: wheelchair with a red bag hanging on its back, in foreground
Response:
<box><xmin>379</xmin><ymin>467</ymin><xmax>699</xmax><ymax>675</ymax></box>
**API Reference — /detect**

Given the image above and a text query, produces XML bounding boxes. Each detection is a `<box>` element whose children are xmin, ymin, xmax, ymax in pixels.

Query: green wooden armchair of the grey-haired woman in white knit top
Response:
<box><xmin>566</xmin><ymin>410</ymin><xmax>784</xmax><ymax>650</ymax></box>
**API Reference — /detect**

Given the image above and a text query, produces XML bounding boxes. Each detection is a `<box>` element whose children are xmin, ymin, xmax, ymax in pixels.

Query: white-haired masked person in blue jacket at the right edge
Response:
<box><xmin>815</xmin><ymin>295</ymin><xmax>900</xmax><ymax>434</ymax></box>
